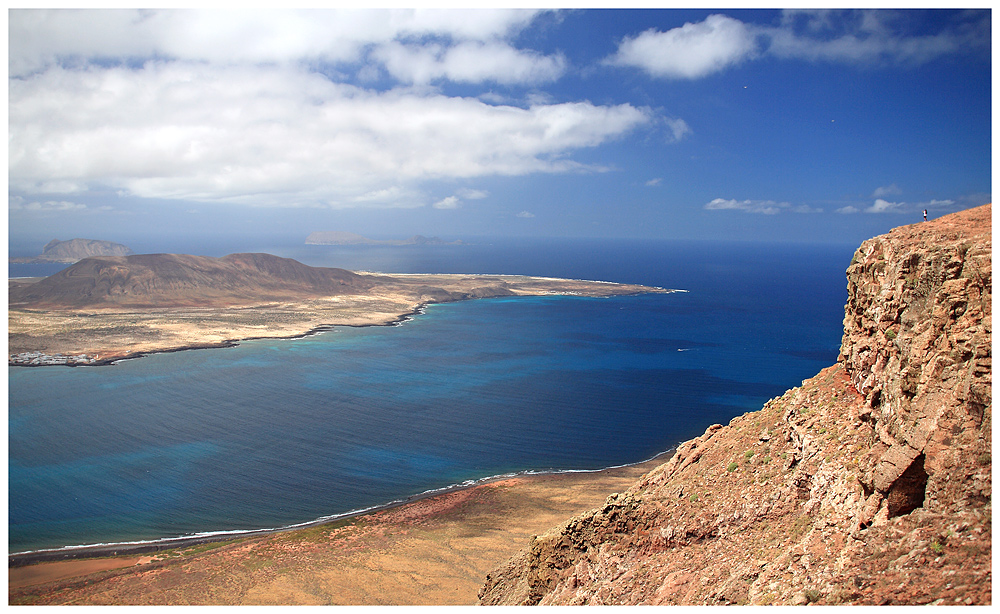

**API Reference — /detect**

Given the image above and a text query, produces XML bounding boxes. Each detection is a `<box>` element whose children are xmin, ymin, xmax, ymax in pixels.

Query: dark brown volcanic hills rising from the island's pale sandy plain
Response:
<box><xmin>9</xmin><ymin>254</ymin><xmax>371</xmax><ymax>308</ymax></box>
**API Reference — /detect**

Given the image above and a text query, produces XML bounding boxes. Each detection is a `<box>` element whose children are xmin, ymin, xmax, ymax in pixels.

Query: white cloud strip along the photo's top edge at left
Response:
<box><xmin>9</xmin><ymin>9</ymin><xmax>538</xmax><ymax>75</ymax></box>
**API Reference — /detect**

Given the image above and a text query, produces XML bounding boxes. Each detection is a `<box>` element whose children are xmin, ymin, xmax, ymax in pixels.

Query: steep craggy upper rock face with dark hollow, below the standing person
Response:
<box><xmin>840</xmin><ymin>206</ymin><xmax>992</xmax><ymax>521</ymax></box>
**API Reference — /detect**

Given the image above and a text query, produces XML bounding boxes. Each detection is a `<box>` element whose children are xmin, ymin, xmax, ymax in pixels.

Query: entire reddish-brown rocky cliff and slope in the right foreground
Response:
<box><xmin>480</xmin><ymin>205</ymin><xmax>992</xmax><ymax>605</ymax></box>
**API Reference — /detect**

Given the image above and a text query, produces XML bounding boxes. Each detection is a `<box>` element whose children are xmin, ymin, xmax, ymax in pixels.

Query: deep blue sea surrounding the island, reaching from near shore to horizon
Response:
<box><xmin>8</xmin><ymin>240</ymin><xmax>852</xmax><ymax>552</ymax></box>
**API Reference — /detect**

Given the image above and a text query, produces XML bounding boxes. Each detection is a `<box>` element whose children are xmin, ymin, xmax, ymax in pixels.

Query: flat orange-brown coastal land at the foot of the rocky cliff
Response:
<box><xmin>8</xmin><ymin>452</ymin><xmax>671</xmax><ymax>605</ymax></box>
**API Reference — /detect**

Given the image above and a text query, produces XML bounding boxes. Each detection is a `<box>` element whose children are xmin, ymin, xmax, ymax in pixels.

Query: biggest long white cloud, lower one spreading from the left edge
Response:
<box><xmin>8</xmin><ymin>62</ymin><xmax>653</xmax><ymax>207</ymax></box>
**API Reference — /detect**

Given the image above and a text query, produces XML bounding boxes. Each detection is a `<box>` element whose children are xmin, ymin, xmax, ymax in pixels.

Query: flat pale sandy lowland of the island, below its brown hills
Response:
<box><xmin>8</xmin><ymin>273</ymin><xmax>672</xmax><ymax>367</ymax></box>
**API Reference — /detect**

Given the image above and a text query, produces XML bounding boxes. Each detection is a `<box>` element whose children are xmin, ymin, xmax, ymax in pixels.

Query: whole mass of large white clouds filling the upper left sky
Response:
<box><xmin>8</xmin><ymin>10</ymin><xmax>652</xmax><ymax>208</ymax></box>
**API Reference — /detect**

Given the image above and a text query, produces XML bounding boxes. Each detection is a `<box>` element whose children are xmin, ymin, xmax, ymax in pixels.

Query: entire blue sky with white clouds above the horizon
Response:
<box><xmin>7</xmin><ymin>9</ymin><xmax>992</xmax><ymax>252</ymax></box>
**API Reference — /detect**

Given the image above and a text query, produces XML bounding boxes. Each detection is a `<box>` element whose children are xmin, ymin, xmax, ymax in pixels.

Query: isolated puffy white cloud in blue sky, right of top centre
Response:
<box><xmin>608</xmin><ymin>15</ymin><xmax>757</xmax><ymax>79</ymax></box>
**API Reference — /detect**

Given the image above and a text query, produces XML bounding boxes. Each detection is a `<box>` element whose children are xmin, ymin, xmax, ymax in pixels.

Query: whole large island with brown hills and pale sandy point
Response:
<box><xmin>7</xmin><ymin>254</ymin><xmax>672</xmax><ymax>366</ymax></box>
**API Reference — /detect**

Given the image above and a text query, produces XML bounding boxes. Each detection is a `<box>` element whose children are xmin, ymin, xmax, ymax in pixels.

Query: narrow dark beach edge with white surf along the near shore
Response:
<box><xmin>7</xmin><ymin>447</ymin><xmax>675</xmax><ymax>568</ymax></box>
